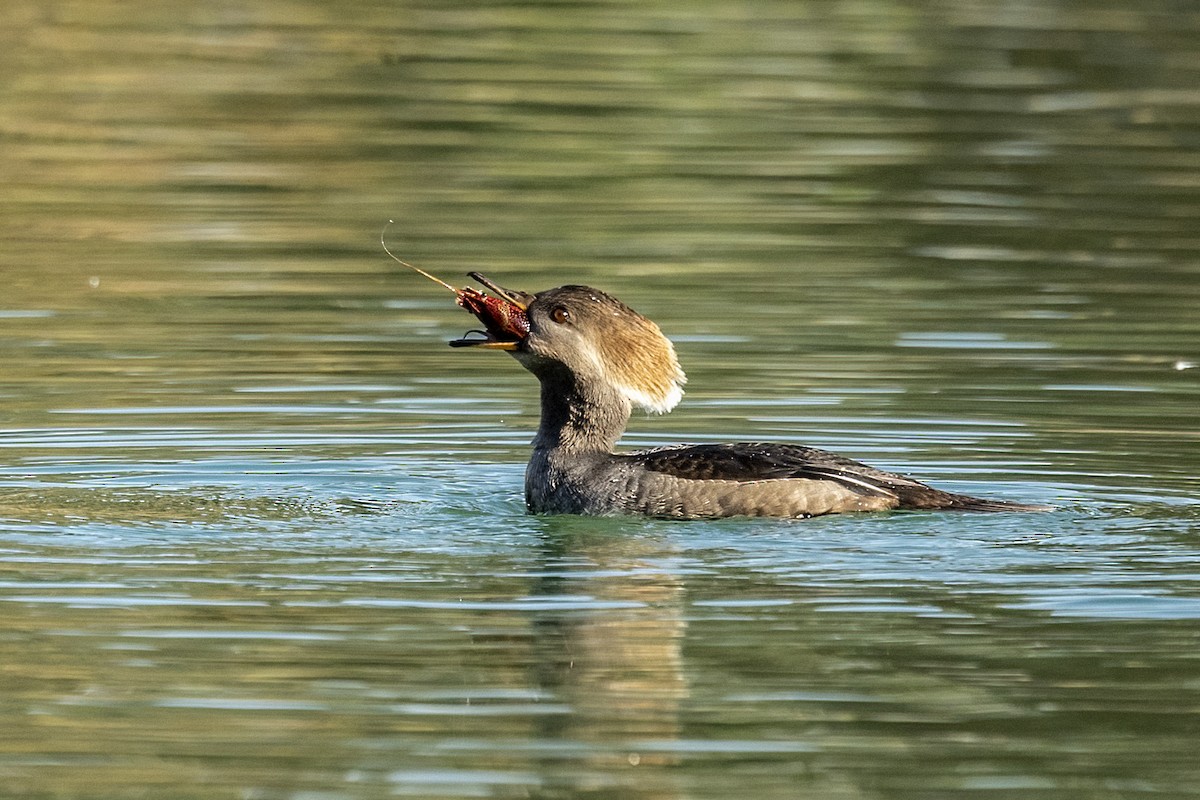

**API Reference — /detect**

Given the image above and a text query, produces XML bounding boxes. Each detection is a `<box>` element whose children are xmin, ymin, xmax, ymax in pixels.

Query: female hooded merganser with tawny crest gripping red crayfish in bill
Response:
<box><xmin>434</xmin><ymin>268</ymin><xmax>1045</xmax><ymax>519</ymax></box>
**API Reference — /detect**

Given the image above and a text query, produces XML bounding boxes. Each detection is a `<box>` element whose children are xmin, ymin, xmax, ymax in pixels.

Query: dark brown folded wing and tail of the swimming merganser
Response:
<box><xmin>624</xmin><ymin>443</ymin><xmax>1033</xmax><ymax>511</ymax></box>
